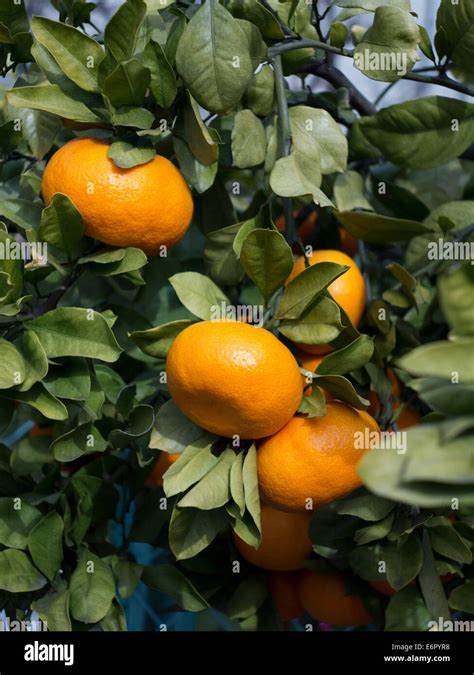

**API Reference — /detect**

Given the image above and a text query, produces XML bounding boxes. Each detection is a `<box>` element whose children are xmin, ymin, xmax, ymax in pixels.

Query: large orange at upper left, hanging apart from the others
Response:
<box><xmin>42</xmin><ymin>138</ymin><xmax>193</xmax><ymax>255</ymax></box>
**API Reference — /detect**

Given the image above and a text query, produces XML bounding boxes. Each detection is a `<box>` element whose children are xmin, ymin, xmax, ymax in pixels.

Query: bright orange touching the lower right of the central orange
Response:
<box><xmin>257</xmin><ymin>401</ymin><xmax>379</xmax><ymax>511</ymax></box>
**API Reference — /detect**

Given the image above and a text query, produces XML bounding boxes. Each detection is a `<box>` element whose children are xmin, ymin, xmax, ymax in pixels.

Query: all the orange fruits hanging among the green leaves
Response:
<box><xmin>42</xmin><ymin>138</ymin><xmax>422</xmax><ymax>625</ymax></box>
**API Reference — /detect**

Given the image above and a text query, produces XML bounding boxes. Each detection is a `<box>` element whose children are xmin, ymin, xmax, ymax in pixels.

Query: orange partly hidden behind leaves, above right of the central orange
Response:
<box><xmin>286</xmin><ymin>250</ymin><xmax>365</xmax><ymax>354</ymax></box>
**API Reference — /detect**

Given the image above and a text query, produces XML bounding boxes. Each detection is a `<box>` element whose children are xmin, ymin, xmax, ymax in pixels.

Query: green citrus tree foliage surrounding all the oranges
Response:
<box><xmin>0</xmin><ymin>0</ymin><xmax>474</xmax><ymax>630</ymax></box>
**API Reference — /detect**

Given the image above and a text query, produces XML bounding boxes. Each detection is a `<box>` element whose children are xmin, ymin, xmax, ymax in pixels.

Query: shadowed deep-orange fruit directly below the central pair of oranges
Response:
<box><xmin>234</xmin><ymin>504</ymin><xmax>313</xmax><ymax>572</ymax></box>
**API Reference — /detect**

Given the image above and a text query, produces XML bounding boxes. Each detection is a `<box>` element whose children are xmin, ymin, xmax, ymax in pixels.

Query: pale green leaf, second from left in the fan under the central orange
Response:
<box><xmin>178</xmin><ymin>448</ymin><xmax>235</xmax><ymax>511</ymax></box>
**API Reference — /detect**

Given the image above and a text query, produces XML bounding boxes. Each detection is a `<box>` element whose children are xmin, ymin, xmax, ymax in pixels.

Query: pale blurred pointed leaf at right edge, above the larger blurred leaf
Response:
<box><xmin>397</xmin><ymin>340</ymin><xmax>474</xmax><ymax>384</ymax></box>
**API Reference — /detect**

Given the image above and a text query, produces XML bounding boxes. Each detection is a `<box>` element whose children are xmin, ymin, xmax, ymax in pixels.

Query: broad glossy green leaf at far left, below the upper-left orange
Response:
<box><xmin>26</xmin><ymin>307</ymin><xmax>122</xmax><ymax>362</ymax></box>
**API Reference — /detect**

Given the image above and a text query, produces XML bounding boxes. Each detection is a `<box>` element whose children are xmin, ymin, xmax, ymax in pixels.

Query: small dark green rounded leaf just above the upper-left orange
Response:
<box><xmin>103</xmin><ymin>59</ymin><xmax>150</xmax><ymax>108</ymax></box>
